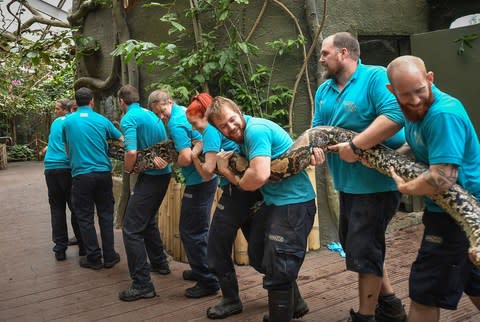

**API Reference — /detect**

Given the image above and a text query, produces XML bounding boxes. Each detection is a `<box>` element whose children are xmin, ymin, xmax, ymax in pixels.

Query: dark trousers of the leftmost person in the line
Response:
<box><xmin>45</xmin><ymin>169</ymin><xmax>82</xmax><ymax>252</ymax></box>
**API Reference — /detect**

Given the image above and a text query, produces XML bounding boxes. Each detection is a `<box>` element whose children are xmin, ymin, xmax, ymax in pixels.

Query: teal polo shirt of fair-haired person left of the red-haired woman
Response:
<box><xmin>167</xmin><ymin>103</ymin><xmax>204</xmax><ymax>186</ymax></box>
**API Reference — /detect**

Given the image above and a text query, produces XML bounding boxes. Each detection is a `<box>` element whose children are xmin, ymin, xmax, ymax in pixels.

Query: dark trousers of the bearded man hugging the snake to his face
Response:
<box><xmin>263</xmin><ymin>200</ymin><xmax>316</xmax><ymax>290</ymax></box>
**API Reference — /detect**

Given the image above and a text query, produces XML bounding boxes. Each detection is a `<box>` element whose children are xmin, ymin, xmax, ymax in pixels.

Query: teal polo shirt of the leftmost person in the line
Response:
<box><xmin>43</xmin><ymin>116</ymin><xmax>70</xmax><ymax>170</ymax></box>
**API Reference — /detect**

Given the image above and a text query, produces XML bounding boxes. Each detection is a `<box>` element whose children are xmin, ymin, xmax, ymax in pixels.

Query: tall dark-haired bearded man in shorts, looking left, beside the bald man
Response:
<box><xmin>312</xmin><ymin>32</ymin><xmax>407</xmax><ymax>322</ymax></box>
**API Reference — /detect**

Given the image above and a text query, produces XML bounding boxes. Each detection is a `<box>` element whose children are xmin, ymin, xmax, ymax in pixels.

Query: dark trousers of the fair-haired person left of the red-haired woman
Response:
<box><xmin>180</xmin><ymin>179</ymin><xmax>218</xmax><ymax>289</ymax></box>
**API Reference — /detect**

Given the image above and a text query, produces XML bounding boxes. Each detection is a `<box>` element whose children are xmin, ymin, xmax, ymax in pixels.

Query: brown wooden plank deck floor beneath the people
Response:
<box><xmin>0</xmin><ymin>162</ymin><xmax>480</xmax><ymax>322</ymax></box>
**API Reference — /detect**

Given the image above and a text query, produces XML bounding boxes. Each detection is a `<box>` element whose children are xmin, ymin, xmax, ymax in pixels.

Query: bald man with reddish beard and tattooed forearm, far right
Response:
<box><xmin>387</xmin><ymin>56</ymin><xmax>480</xmax><ymax>322</ymax></box>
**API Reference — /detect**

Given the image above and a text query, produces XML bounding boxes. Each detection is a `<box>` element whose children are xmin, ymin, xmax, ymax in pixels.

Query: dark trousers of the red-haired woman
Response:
<box><xmin>207</xmin><ymin>184</ymin><xmax>263</xmax><ymax>277</ymax></box>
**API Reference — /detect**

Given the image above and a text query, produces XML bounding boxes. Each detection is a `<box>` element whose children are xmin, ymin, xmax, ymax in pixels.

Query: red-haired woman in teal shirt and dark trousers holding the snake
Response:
<box><xmin>187</xmin><ymin>93</ymin><xmax>263</xmax><ymax>319</ymax></box>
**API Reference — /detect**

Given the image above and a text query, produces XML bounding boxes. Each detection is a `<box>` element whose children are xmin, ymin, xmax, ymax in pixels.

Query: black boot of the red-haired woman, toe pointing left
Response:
<box><xmin>207</xmin><ymin>272</ymin><xmax>243</xmax><ymax>320</ymax></box>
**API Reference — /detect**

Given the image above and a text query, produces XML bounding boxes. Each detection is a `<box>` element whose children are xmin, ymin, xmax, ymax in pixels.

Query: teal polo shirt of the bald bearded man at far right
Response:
<box><xmin>405</xmin><ymin>86</ymin><xmax>480</xmax><ymax>212</ymax></box>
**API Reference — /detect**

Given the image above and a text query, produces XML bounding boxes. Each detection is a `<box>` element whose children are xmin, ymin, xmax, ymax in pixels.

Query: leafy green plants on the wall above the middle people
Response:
<box><xmin>112</xmin><ymin>0</ymin><xmax>296</xmax><ymax>125</ymax></box>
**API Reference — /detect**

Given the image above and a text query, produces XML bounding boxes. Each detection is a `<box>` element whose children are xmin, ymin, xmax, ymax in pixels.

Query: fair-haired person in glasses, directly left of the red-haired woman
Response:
<box><xmin>148</xmin><ymin>89</ymin><xmax>219</xmax><ymax>298</ymax></box>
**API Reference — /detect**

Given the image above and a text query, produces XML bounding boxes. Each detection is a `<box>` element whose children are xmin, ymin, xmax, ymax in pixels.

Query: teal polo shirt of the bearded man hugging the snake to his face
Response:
<box><xmin>240</xmin><ymin>116</ymin><xmax>315</xmax><ymax>206</ymax></box>
